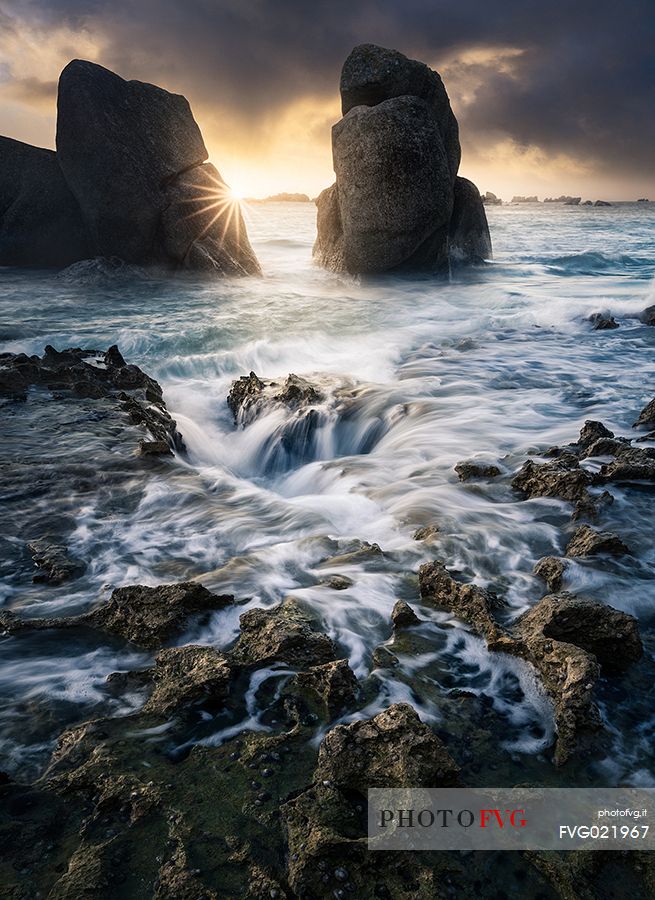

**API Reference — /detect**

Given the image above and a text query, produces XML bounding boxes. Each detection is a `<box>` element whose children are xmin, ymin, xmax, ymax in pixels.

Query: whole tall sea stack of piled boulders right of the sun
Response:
<box><xmin>314</xmin><ymin>44</ymin><xmax>491</xmax><ymax>274</ymax></box>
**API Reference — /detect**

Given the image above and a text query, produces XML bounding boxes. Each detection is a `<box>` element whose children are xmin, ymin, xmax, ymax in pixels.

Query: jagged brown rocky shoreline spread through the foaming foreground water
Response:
<box><xmin>0</xmin><ymin>347</ymin><xmax>655</xmax><ymax>900</ymax></box>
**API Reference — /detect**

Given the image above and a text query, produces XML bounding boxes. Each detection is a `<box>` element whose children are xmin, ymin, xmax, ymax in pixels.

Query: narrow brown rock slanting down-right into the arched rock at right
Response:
<box><xmin>418</xmin><ymin>561</ymin><xmax>503</xmax><ymax>643</ymax></box>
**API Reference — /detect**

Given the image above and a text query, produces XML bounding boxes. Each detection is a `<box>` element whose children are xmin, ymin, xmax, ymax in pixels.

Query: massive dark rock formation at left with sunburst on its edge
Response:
<box><xmin>0</xmin><ymin>59</ymin><xmax>260</xmax><ymax>275</ymax></box>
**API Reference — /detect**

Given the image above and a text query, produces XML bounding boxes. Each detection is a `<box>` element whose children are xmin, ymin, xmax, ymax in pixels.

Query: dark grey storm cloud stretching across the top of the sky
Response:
<box><xmin>5</xmin><ymin>0</ymin><xmax>655</xmax><ymax>174</ymax></box>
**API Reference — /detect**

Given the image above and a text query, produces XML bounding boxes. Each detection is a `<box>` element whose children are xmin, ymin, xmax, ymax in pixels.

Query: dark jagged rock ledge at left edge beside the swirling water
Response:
<box><xmin>0</xmin><ymin>345</ymin><xmax>184</xmax><ymax>450</ymax></box>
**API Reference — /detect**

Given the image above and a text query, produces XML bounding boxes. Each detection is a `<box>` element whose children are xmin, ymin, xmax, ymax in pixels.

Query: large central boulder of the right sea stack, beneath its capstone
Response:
<box><xmin>316</xmin><ymin>96</ymin><xmax>453</xmax><ymax>273</ymax></box>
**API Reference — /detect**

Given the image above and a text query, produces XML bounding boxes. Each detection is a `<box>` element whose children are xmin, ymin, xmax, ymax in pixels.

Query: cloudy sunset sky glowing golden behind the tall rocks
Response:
<box><xmin>0</xmin><ymin>0</ymin><xmax>655</xmax><ymax>200</ymax></box>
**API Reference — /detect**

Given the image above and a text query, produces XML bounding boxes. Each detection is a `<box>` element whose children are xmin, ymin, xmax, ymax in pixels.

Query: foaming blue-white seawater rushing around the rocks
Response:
<box><xmin>0</xmin><ymin>203</ymin><xmax>655</xmax><ymax>786</ymax></box>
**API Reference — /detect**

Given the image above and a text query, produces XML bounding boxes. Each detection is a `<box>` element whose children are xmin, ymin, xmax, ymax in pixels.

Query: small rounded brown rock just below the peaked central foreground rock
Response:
<box><xmin>283</xmin><ymin>659</ymin><xmax>358</xmax><ymax>722</ymax></box>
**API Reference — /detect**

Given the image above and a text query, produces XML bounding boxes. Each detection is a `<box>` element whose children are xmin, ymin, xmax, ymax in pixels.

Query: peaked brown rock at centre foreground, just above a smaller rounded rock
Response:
<box><xmin>229</xmin><ymin>597</ymin><xmax>336</xmax><ymax>669</ymax></box>
